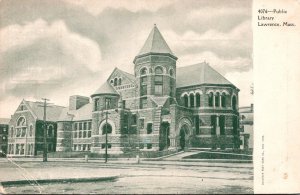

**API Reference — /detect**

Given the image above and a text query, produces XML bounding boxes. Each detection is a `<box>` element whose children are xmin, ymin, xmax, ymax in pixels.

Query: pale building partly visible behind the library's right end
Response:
<box><xmin>239</xmin><ymin>104</ymin><xmax>254</xmax><ymax>149</ymax></box>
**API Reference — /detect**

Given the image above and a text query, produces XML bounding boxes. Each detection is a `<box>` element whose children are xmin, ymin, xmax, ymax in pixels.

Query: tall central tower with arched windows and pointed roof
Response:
<box><xmin>133</xmin><ymin>25</ymin><xmax>177</xmax><ymax>107</ymax></box>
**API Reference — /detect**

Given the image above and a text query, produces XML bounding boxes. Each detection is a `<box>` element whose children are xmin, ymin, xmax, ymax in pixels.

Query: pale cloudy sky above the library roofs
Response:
<box><xmin>0</xmin><ymin>0</ymin><xmax>253</xmax><ymax>117</ymax></box>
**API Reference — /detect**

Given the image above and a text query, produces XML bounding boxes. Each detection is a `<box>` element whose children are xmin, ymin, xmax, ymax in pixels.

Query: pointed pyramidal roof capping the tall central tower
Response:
<box><xmin>138</xmin><ymin>25</ymin><xmax>174</xmax><ymax>55</ymax></box>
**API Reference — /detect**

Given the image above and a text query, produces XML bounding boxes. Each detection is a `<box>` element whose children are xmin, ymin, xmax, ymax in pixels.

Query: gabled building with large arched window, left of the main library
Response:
<box><xmin>7</xmin><ymin>100</ymin><xmax>64</xmax><ymax>156</ymax></box>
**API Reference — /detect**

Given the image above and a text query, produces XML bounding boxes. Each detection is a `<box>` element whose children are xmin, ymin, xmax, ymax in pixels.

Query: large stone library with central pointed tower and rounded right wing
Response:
<box><xmin>57</xmin><ymin>26</ymin><xmax>240</xmax><ymax>153</ymax></box>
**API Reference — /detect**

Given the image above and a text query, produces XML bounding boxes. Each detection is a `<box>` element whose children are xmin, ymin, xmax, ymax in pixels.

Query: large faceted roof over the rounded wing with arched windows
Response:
<box><xmin>176</xmin><ymin>62</ymin><xmax>234</xmax><ymax>88</ymax></box>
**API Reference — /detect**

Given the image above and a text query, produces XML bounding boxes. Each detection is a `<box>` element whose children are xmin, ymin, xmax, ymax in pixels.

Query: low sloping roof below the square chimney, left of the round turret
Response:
<box><xmin>58</xmin><ymin>103</ymin><xmax>93</xmax><ymax>121</ymax></box>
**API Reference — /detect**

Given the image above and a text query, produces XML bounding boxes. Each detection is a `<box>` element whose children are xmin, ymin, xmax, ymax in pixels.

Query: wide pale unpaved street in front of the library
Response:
<box><xmin>0</xmin><ymin>160</ymin><xmax>253</xmax><ymax>194</ymax></box>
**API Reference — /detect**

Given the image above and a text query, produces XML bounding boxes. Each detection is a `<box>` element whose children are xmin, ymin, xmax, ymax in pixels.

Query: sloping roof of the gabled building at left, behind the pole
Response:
<box><xmin>23</xmin><ymin>100</ymin><xmax>65</xmax><ymax>122</ymax></box>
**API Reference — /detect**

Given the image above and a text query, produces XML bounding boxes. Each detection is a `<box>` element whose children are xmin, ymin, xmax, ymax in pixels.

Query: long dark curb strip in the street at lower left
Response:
<box><xmin>1</xmin><ymin>176</ymin><xmax>119</xmax><ymax>186</ymax></box>
